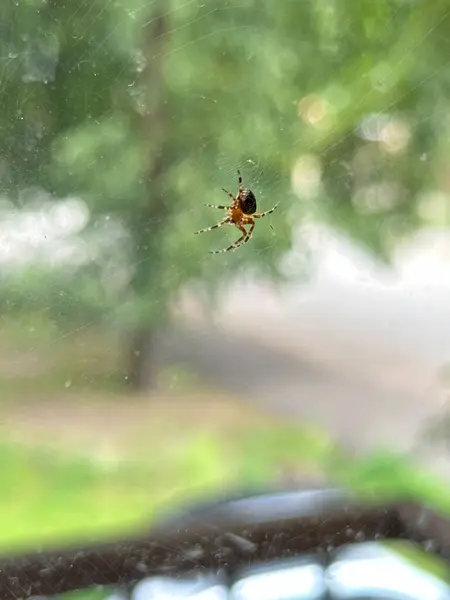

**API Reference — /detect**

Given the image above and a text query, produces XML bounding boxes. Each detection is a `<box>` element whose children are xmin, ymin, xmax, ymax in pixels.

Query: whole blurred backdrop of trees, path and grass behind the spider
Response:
<box><xmin>0</xmin><ymin>0</ymin><xmax>450</xmax><ymax>564</ymax></box>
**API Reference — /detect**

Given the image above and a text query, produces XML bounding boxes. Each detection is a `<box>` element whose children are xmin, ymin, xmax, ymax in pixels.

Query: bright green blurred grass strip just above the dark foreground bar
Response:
<box><xmin>0</xmin><ymin>426</ymin><xmax>450</xmax><ymax>551</ymax></box>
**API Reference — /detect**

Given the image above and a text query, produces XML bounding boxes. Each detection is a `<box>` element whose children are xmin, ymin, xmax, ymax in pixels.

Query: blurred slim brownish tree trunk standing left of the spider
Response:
<box><xmin>126</xmin><ymin>0</ymin><xmax>171</xmax><ymax>391</ymax></box>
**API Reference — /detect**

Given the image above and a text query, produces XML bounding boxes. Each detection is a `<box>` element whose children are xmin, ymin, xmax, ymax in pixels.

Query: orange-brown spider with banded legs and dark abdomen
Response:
<box><xmin>195</xmin><ymin>169</ymin><xmax>278</xmax><ymax>254</ymax></box>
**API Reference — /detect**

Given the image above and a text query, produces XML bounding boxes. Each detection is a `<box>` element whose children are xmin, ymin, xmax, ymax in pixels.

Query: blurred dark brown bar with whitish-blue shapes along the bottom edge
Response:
<box><xmin>0</xmin><ymin>489</ymin><xmax>450</xmax><ymax>600</ymax></box>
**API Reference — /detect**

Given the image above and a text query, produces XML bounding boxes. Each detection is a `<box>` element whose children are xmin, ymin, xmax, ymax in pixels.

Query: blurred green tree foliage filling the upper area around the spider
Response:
<box><xmin>0</xmin><ymin>0</ymin><xmax>450</xmax><ymax>380</ymax></box>
